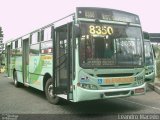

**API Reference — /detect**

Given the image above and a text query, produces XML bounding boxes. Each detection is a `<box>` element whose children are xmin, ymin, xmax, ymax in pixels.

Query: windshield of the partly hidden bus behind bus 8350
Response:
<box><xmin>144</xmin><ymin>41</ymin><xmax>153</xmax><ymax>66</ymax></box>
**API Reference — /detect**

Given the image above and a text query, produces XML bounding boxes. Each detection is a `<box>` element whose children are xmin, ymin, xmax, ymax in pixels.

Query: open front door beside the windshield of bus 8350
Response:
<box><xmin>54</xmin><ymin>24</ymin><xmax>72</xmax><ymax>99</ymax></box>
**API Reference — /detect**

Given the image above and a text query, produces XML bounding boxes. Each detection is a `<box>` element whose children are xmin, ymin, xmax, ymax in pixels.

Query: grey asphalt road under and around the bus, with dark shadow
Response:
<box><xmin>0</xmin><ymin>74</ymin><xmax>160</xmax><ymax>120</ymax></box>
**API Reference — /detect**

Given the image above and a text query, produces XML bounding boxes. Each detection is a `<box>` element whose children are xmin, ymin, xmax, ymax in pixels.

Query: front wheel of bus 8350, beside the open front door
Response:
<box><xmin>45</xmin><ymin>78</ymin><xmax>60</xmax><ymax>104</ymax></box>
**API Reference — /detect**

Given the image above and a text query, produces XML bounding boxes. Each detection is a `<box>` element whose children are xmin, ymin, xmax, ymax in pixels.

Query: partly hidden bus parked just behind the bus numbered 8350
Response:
<box><xmin>143</xmin><ymin>32</ymin><xmax>155</xmax><ymax>82</ymax></box>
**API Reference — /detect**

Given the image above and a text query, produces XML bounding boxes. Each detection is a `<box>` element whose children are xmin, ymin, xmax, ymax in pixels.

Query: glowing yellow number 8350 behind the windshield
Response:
<box><xmin>89</xmin><ymin>25</ymin><xmax>113</xmax><ymax>35</ymax></box>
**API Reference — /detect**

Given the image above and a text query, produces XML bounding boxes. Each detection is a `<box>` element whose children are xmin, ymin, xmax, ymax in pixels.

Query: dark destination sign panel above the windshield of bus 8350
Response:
<box><xmin>77</xmin><ymin>7</ymin><xmax>140</xmax><ymax>24</ymax></box>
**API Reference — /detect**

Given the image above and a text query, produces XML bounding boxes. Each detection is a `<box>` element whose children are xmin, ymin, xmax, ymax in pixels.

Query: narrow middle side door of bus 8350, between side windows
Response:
<box><xmin>22</xmin><ymin>38</ymin><xmax>29</xmax><ymax>85</ymax></box>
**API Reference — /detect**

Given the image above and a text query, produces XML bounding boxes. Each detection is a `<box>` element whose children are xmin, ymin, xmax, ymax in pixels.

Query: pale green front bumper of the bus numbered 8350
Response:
<box><xmin>75</xmin><ymin>83</ymin><xmax>146</xmax><ymax>102</ymax></box>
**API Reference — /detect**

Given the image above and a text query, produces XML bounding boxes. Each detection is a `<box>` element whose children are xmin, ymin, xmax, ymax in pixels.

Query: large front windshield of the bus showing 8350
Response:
<box><xmin>80</xmin><ymin>22</ymin><xmax>143</xmax><ymax>68</ymax></box>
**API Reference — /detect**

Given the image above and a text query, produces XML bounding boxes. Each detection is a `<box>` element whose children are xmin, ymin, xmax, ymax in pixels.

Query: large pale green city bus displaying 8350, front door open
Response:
<box><xmin>6</xmin><ymin>7</ymin><xmax>146</xmax><ymax>104</ymax></box>
